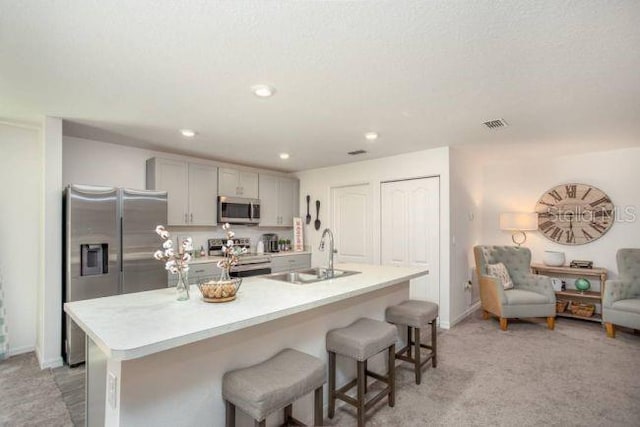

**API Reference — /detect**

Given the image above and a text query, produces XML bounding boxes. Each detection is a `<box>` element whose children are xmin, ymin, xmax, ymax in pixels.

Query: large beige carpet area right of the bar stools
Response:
<box><xmin>326</xmin><ymin>312</ymin><xmax>640</xmax><ymax>427</ymax></box>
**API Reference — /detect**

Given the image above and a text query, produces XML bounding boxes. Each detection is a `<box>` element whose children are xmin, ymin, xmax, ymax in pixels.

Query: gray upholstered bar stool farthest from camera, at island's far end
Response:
<box><xmin>386</xmin><ymin>300</ymin><xmax>438</xmax><ymax>384</ymax></box>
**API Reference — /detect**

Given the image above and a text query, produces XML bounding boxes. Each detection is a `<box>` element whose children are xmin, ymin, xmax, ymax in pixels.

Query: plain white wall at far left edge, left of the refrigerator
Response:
<box><xmin>0</xmin><ymin>124</ymin><xmax>42</xmax><ymax>355</ymax></box>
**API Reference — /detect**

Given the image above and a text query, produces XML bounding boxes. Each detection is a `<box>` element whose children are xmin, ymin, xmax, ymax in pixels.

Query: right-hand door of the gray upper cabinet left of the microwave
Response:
<box><xmin>189</xmin><ymin>163</ymin><xmax>218</xmax><ymax>225</ymax></box>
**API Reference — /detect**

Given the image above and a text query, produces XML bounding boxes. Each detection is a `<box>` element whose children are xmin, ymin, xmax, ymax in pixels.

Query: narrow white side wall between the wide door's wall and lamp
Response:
<box><xmin>450</xmin><ymin>147</ymin><xmax>483</xmax><ymax>325</ymax></box>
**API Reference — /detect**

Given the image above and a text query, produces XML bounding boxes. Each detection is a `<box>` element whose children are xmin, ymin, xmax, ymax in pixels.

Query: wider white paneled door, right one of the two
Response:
<box><xmin>380</xmin><ymin>177</ymin><xmax>440</xmax><ymax>304</ymax></box>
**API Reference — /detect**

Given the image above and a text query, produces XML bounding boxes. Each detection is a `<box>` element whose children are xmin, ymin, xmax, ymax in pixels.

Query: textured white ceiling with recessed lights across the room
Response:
<box><xmin>0</xmin><ymin>0</ymin><xmax>640</xmax><ymax>170</ymax></box>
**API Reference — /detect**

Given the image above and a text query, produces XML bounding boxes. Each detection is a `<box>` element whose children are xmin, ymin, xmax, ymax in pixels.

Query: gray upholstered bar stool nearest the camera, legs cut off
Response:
<box><xmin>222</xmin><ymin>349</ymin><xmax>325</xmax><ymax>427</ymax></box>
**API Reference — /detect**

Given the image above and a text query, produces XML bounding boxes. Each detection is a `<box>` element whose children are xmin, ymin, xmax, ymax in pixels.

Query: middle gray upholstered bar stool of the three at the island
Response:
<box><xmin>327</xmin><ymin>318</ymin><xmax>398</xmax><ymax>427</ymax></box>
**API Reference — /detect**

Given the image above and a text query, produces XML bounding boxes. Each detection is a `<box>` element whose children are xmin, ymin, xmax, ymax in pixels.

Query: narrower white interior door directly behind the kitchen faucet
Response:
<box><xmin>331</xmin><ymin>184</ymin><xmax>373</xmax><ymax>264</ymax></box>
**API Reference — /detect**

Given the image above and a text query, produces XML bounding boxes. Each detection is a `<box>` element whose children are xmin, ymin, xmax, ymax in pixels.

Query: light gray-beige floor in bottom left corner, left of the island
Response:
<box><xmin>0</xmin><ymin>353</ymin><xmax>73</xmax><ymax>427</ymax></box>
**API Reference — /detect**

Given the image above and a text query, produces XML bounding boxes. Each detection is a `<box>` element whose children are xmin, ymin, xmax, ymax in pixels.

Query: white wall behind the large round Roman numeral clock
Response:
<box><xmin>482</xmin><ymin>148</ymin><xmax>640</xmax><ymax>277</ymax></box>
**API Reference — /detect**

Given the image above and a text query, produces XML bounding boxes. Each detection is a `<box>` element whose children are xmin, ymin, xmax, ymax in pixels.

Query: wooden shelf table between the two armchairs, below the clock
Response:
<box><xmin>531</xmin><ymin>264</ymin><xmax>607</xmax><ymax>323</ymax></box>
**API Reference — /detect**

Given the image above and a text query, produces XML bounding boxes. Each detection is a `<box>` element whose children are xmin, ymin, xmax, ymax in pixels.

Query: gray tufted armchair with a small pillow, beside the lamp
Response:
<box><xmin>473</xmin><ymin>246</ymin><xmax>556</xmax><ymax>331</ymax></box>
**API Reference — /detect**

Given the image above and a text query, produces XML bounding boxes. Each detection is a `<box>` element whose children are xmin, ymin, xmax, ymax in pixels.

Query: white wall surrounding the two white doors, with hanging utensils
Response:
<box><xmin>296</xmin><ymin>147</ymin><xmax>450</xmax><ymax>327</ymax></box>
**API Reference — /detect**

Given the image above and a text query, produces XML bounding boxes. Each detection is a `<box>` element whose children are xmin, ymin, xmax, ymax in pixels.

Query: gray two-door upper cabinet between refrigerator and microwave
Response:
<box><xmin>147</xmin><ymin>157</ymin><xmax>218</xmax><ymax>225</ymax></box>
